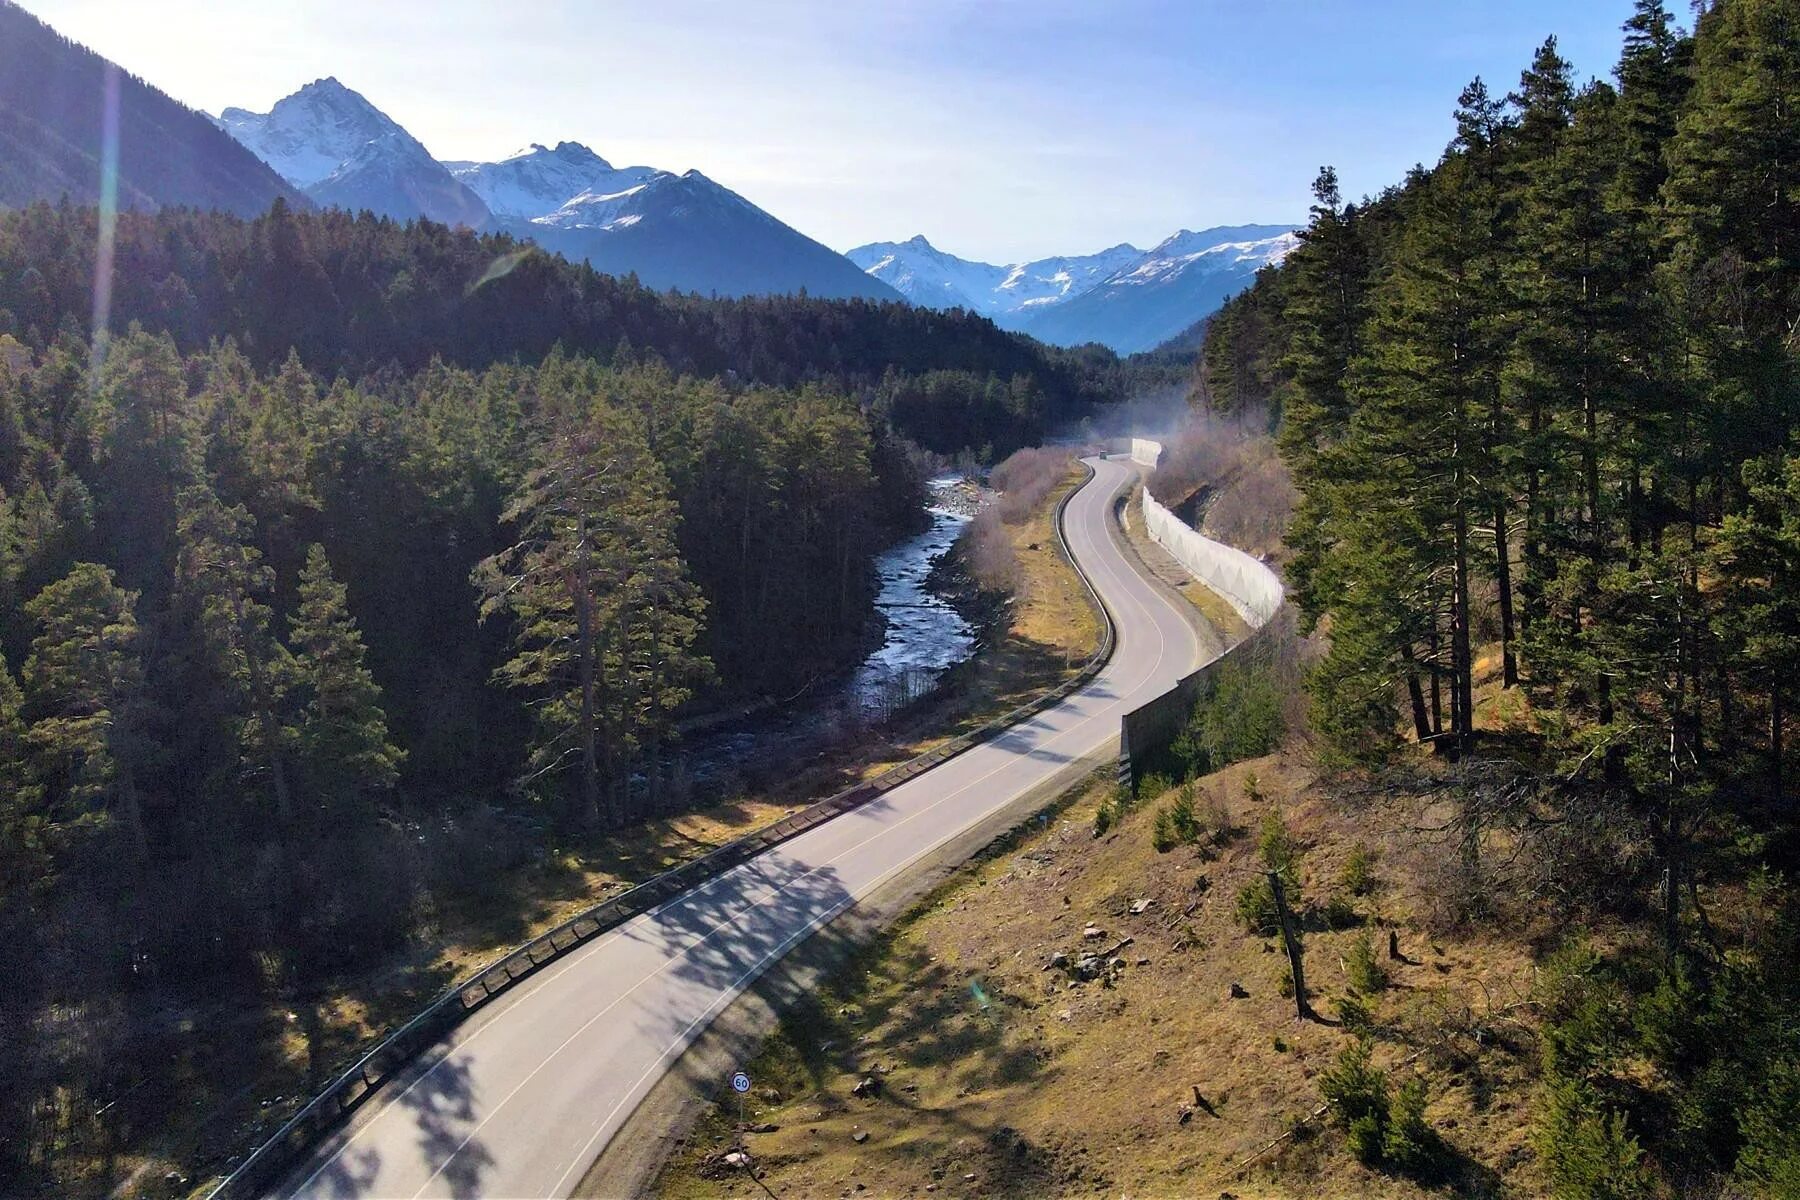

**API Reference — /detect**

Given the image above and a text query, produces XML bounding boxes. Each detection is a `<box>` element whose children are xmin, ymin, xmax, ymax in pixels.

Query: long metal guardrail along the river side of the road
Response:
<box><xmin>209</xmin><ymin>462</ymin><xmax>1118</xmax><ymax>1200</ymax></box>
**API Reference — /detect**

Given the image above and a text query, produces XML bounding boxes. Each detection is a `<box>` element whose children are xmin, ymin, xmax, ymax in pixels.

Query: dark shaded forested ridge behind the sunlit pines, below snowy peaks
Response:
<box><xmin>0</xmin><ymin>203</ymin><xmax>1141</xmax><ymax>455</ymax></box>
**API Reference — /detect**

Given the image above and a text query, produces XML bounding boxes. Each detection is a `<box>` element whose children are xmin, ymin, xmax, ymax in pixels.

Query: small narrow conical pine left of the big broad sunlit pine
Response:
<box><xmin>290</xmin><ymin>543</ymin><xmax>405</xmax><ymax>817</ymax></box>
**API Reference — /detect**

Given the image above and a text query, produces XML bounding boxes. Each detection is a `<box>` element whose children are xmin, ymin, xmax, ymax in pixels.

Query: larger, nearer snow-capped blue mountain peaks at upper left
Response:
<box><xmin>218</xmin><ymin>79</ymin><xmax>900</xmax><ymax>300</ymax></box>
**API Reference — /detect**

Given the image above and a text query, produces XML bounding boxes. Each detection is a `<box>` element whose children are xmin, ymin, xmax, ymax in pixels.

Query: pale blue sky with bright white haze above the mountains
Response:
<box><xmin>23</xmin><ymin>0</ymin><xmax>1648</xmax><ymax>261</ymax></box>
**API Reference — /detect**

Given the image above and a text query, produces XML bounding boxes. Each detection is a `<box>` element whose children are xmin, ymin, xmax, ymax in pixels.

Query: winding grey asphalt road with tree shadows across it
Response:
<box><xmin>275</xmin><ymin>459</ymin><xmax>1201</xmax><ymax>1200</ymax></box>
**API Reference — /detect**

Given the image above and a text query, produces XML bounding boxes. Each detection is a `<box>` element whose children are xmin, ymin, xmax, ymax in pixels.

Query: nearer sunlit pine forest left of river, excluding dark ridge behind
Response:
<box><xmin>0</xmin><ymin>323</ymin><xmax>943</xmax><ymax>1189</ymax></box>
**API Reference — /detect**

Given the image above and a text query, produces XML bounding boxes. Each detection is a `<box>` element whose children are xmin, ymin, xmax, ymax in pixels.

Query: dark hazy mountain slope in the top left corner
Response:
<box><xmin>0</xmin><ymin>0</ymin><xmax>297</xmax><ymax>216</ymax></box>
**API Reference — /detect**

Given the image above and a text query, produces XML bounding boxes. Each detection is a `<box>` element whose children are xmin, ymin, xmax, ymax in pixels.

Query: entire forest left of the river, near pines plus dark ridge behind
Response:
<box><xmin>0</xmin><ymin>178</ymin><xmax>1174</xmax><ymax>1193</ymax></box>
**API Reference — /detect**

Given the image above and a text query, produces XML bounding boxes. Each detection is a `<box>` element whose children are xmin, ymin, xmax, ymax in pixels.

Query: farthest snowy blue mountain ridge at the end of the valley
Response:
<box><xmin>844</xmin><ymin>225</ymin><xmax>1298</xmax><ymax>354</ymax></box>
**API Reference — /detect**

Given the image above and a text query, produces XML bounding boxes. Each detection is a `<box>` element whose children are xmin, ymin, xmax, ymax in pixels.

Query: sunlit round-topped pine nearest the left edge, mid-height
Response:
<box><xmin>25</xmin><ymin>563</ymin><xmax>148</xmax><ymax>858</ymax></box>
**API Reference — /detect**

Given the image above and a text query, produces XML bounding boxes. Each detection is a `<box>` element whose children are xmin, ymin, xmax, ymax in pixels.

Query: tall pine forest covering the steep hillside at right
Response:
<box><xmin>1201</xmin><ymin>0</ymin><xmax>1800</xmax><ymax>1196</ymax></box>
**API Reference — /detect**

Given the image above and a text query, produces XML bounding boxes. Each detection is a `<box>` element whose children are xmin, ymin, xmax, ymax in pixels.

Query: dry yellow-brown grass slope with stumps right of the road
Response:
<box><xmin>662</xmin><ymin>752</ymin><xmax>1541</xmax><ymax>1200</ymax></box>
